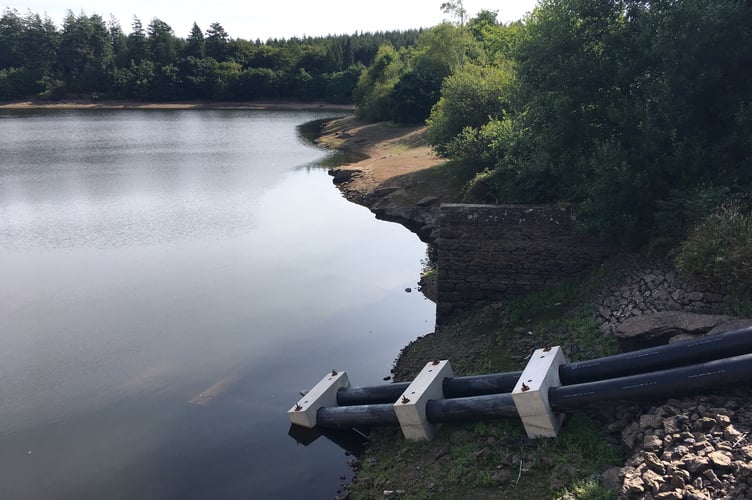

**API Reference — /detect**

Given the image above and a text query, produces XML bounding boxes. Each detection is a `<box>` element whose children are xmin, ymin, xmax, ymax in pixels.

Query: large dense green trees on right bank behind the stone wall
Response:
<box><xmin>420</xmin><ymin>0</ymin><xmax>752</xmax><ymax>250</ymax></box>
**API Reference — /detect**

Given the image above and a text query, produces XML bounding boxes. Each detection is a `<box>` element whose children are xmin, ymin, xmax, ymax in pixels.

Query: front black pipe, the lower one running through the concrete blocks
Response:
<box><xmin>317</xmin><ymin>354</ymin><xmax>752</xmax><ymax>428</ymax></box>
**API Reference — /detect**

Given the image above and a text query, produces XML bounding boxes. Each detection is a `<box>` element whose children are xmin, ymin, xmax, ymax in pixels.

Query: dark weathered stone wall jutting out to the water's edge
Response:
<box><xmin>436</xmin><ymin>204</ymin><xmax>613</xmax><ymax>325</ymax></box>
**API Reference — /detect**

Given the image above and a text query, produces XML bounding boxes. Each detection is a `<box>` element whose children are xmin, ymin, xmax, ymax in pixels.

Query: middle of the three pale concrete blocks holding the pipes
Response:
<box><xmin>394</xmin><ymin>360</ymin><xmax>454</xmax><ymax>441</ymax></box>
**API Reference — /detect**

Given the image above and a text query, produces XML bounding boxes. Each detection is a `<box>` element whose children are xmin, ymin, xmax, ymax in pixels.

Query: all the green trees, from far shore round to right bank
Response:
<box><xmin>0</xmin><ymin>0</ymin><xmax>752</xmax><ymax>290</ymax></box>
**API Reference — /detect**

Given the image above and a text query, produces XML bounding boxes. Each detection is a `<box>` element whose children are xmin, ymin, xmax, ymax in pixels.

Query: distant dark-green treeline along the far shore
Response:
<box><xmin>0</xmin><ymin>9</ymin><xmax>420</xmax><ymax>103</ymax></box>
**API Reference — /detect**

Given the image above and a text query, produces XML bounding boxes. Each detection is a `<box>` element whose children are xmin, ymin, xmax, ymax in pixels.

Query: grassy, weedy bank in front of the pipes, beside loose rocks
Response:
<box><xmin>350</xmin><ymin>414</ymin><xmax>624</xmax><ymax>499</ymax></box>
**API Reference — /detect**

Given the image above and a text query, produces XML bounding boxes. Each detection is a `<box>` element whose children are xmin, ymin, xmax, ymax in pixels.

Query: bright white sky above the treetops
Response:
<box><xmin>8</xmin><ymin>0</ymin><xmax>537</xmax><ymax>41</ymax></box>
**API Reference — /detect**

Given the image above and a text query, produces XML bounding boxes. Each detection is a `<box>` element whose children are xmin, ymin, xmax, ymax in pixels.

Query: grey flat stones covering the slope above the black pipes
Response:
<box><xmin>598</xmin><ymin>263</ymin><xmax>734</xmax><ymax>333</ymax></box>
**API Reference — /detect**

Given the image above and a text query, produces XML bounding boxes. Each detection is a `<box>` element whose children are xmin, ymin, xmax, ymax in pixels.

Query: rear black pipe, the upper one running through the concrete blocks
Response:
<box><xmin>337</xmin><ymin>327</ymin><xmax>752</xmax><ymax>406</ymax></box>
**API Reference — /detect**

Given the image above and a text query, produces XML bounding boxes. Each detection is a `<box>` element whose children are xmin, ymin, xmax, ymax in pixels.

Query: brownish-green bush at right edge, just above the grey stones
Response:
<box><xmin>676</xmin><ymin>201</ymin><xmax>752</xmax><ymax>294</ymax></box>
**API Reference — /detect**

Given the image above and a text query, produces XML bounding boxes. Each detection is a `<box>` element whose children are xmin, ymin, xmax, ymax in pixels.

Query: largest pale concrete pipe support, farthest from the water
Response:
<box><xmin>512</xmin><ymin>346</ymin><xmax>567</xmax><ymax>438</ymax></box>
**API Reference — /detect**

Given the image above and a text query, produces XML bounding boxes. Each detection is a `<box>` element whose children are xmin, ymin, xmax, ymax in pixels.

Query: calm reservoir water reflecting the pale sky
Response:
<box><xmin>0</xmin><ymin>110</ymin><xmax>434</xmax><ymax>499</ymax></box>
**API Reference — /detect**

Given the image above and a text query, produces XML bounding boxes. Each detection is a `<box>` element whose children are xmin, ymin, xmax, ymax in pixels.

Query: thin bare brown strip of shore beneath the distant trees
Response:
<box><xmin>0</xmin><ymin>99</ymin><xmax>355</xmax><ymax>111</ymax></box>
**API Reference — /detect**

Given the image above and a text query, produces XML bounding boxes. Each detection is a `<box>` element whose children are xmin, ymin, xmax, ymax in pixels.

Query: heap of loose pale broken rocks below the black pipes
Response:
<box><xmin>612</xmin><ymin>390</ymin><xmax>752</xmax><ymax>500</ymax></box>
